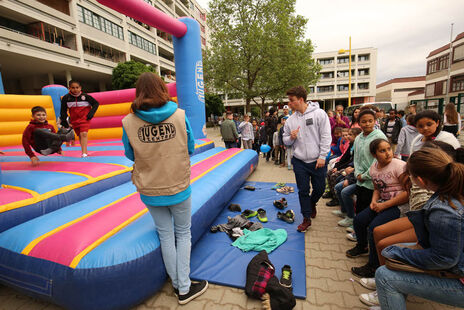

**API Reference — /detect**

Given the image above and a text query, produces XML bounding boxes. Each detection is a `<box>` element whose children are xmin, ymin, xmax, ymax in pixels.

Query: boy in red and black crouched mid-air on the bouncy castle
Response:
<box><xmin>22</xmin><ymin>106</ymin><xmax>74</xmax><ymax>166</ymax></box>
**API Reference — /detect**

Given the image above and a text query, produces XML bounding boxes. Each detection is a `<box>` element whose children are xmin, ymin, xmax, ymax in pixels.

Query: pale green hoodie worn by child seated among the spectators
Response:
<box><xmin>353</xmin><ymin>129</ymin><xmax>387</xmax><ymax>190</ymax></box>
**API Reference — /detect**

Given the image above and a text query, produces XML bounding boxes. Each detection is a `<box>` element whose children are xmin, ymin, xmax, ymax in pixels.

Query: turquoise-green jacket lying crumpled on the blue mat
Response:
<box><xmin>232</xmin><ymin>228</ymin><xmax>287</xmax><ymax>253</ymax></box>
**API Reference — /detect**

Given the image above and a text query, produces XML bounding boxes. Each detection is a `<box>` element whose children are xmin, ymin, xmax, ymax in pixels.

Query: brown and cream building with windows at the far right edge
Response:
<box><xmin>425</xmin><ymin>32</ymin><xmax>464</xmax><ymax>105</ymax></box>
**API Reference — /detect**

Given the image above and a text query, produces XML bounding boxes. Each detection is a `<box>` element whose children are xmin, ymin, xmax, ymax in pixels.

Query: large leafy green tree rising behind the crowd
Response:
<box><xmin>205</xmin><ymin>0</ymin><xmax>320</xmax><ymax>113</ymax></box>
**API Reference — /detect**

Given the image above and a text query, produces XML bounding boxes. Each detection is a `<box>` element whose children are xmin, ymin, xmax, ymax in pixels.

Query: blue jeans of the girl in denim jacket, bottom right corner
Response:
<box><xmin>375</xmin><ymin>266</ymin><xmax>464</xmax><ymax>310</ymax></box>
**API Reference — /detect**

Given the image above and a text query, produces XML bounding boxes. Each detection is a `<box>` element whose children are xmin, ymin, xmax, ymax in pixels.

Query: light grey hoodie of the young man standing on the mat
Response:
<box><xmin>283</xmin><ymin>101</ymin><xmax>332</xmax><ymax>163</ymax></box>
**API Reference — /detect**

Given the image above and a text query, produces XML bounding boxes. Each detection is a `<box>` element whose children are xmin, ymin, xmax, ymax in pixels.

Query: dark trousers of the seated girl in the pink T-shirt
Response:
<box><xmin>353</xmin><ymin>207</ymin><xmax>400</xmax><ymax>267</ymax></box>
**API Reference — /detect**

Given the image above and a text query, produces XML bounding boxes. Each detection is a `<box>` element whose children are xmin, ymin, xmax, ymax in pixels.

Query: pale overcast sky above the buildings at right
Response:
<box><xmin>197</xmin><ymin>0</ymin><xmax>464</xmax><ymax>84</ymax></box>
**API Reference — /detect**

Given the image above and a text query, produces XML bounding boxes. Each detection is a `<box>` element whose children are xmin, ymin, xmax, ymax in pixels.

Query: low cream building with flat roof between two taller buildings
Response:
<box><xmin>375</xmin><ymin>76</ymin><xmax>425</xmax><ymax>110</ymax></box>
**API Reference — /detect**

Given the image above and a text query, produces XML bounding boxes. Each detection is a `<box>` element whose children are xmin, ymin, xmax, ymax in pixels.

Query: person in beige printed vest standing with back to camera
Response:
<box><xmin>122</xmin><ymin>72</ymin><xmax>208</xmax><ymax>304</ymax></box>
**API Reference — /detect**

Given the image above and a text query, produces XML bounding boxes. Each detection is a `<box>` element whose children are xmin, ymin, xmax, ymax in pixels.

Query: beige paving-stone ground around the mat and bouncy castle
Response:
<box><xmin>0</xmin><ymin>129</ymin><xmax>455</xmax><ymax>310</ymax></box>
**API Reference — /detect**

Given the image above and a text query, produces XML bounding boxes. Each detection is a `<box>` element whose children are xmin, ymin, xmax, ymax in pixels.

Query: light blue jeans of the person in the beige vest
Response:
<box><xmin>147</xmin><ymin>197</ymin><xmax>192</xmax><ymax>294</ymax></box>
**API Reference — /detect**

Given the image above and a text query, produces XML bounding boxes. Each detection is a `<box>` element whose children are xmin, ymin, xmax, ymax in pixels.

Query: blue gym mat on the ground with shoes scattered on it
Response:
<box><xmin>190</xmin><ymin>182</ymin><xmax>306</xmax><ymax>299</ymax></box>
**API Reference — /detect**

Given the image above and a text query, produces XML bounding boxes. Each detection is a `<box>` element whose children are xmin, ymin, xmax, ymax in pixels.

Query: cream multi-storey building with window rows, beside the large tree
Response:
<box><xmin>308</xmin><ymin>47</ymin><xmax>377</xmax><ymax>110</ymax></box>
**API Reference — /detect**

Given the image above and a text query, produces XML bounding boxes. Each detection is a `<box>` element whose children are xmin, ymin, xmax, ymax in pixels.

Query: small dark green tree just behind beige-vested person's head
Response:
<box><xmin>111</xmin><ymin>60</ymin><xmax>155</xmax><ymax>89</ymax></box>
